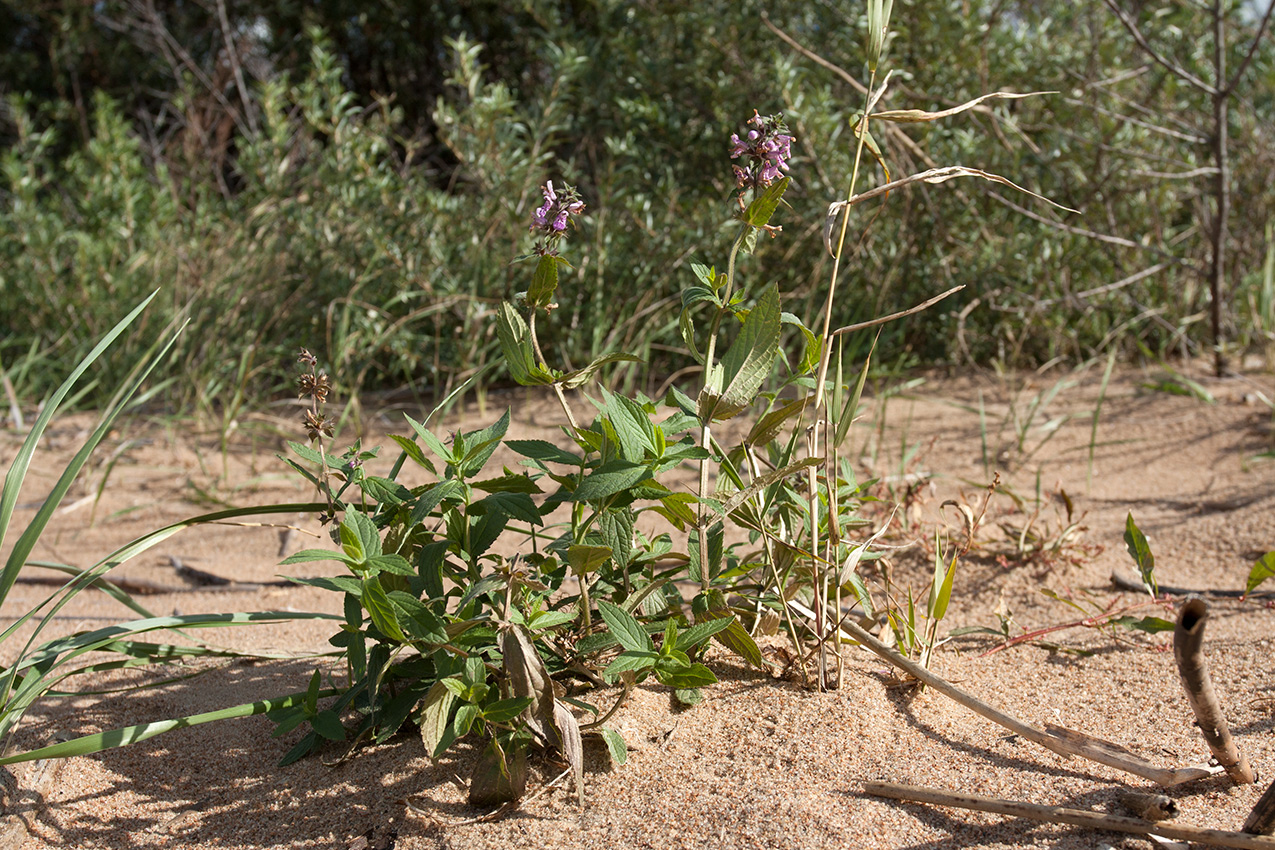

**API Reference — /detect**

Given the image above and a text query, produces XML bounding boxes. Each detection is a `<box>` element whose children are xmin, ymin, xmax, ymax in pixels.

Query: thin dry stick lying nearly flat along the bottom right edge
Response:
<box><xmin>863</xmin><ymin>782</ymin><xmax>1275</xmax><ymax>850</ymax></box>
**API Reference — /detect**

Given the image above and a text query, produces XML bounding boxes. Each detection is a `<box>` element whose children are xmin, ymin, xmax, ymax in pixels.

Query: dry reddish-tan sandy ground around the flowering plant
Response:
<box><xmin>0</xmin><ymin>361</ymin><xmax>1275</xmax><ymax>850</ymax></box>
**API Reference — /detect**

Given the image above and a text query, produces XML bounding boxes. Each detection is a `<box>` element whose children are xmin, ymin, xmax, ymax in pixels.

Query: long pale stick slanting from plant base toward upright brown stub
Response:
<box><xmin>842</xmin><ymin>619</ymin><xmax>1218</xmax><ymax>790</ymax></box>
